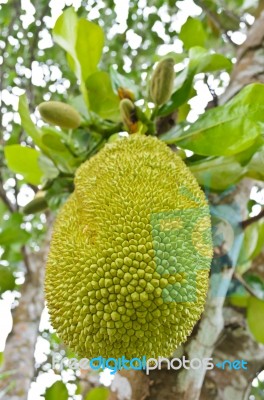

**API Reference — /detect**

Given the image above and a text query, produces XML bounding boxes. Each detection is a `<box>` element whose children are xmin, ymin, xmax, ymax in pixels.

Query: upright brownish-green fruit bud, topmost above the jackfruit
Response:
<box><xmin>150</xmin><ymin>58</ymin><xmax>175</xmax><ymax>106</ymax></box>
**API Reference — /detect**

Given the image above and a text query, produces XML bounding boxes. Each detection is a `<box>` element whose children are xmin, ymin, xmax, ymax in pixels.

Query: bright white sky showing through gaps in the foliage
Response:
<box><xmin>0</xmin><ymin>0</ymin><xmax>264</xmax><ymax>400</ymax></box>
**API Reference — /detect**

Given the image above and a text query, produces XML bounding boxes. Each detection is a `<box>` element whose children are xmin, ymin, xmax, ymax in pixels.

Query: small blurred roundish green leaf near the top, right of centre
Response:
<box><xmin>179</xmin><ymin>17</ymin><xmax>206</xmax><ymax>49</ymax></box>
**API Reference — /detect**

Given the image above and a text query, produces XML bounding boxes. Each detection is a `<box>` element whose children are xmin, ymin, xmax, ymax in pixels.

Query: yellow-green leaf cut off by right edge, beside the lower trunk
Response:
<box><xmin>247</xmin><ymin>297</ymin><xmax>264</xmax><ymax>343</ymax></box>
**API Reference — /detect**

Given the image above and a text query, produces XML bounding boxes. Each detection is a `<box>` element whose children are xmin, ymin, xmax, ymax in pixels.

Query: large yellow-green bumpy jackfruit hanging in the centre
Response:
<box><xmin>45</xmin><ymin>134</ymin><xmax>212</xmax><ymax>359</ymax></box>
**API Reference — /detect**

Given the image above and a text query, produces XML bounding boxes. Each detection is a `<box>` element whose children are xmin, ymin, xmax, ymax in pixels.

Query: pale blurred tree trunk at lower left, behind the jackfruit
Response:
<box><xmin>0</xmin><ymin>220</ymin><xmax>52</xmax><ymax>400</ymax></box>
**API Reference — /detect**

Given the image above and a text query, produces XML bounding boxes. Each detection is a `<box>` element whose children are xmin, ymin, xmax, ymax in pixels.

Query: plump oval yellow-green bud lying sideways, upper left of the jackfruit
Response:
<box><xmin>38</xmin><ymin>101</ymin><xmax>81</xmax><ymax>129</ymax></box>
